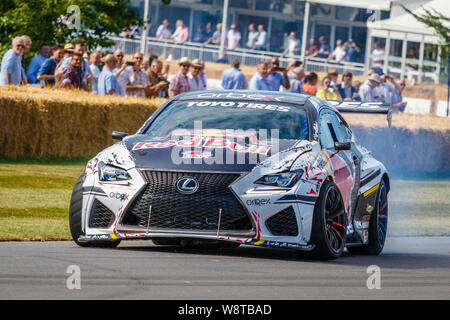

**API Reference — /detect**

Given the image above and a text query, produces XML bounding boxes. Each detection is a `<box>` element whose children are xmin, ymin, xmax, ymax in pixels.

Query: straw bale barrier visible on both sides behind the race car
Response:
<box><xmin>0</xmin><ymin>87</ymin><xmax>450</xmax><ymax>172</ymax></box>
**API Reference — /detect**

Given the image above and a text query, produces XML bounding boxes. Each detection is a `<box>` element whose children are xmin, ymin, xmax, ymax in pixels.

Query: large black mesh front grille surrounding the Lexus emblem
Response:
<box><xmin>122</xmin><ymin>170</ymin><xmax>252</xmax><ymax>232</ymax></box>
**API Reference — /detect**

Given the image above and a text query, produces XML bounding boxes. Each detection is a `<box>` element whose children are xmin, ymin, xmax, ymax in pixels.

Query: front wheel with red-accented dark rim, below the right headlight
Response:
<box><xmin>310</xmin><ymin>180</ymin><xmax>346</xmax><ymax>260</ymax></box>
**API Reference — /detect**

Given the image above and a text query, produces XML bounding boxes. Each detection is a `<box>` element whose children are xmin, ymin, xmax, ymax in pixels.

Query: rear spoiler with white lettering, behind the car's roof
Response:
<box><xmin>328</xmin><ymin>100</ymin><xmax>392</xmax><ymax>128</ymax></box>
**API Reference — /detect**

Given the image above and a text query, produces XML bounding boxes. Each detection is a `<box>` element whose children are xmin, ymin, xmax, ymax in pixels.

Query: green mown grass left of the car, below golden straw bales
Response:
<box><xmin>0</xmin><ymin>160</ymin><xmax>86</xmax><ymax>240</ymax></box>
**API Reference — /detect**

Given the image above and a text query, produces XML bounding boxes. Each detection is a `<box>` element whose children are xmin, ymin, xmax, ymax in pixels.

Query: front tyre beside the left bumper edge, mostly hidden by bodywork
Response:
<box><xmin>69</xmin><ymin>173</ymin><xmax>120</xmax><ymax>248</ymax></box>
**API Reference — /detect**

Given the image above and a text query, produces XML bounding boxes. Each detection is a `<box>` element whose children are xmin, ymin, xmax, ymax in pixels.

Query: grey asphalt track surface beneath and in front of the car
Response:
<box><xmin>0</xmin><ymin>237</ymin><xmax>450</xmax><ymax>299</ymax></box>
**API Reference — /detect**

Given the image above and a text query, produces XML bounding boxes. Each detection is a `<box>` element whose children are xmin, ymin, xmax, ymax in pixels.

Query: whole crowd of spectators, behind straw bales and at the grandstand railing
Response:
<box><xmin>0</xmin><ymin>33</ymin><xmax>406</xmax><ymax>111</ymax></box>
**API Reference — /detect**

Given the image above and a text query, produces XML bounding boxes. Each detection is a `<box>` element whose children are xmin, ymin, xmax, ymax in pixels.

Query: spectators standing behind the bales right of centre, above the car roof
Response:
<box><xmin>222</xmin><ymin>57</ymin><xmax>406</xmax><ymax>112</ymax></box>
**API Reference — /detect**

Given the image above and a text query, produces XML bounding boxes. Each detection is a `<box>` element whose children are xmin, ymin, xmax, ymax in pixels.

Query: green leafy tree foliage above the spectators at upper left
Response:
<box><xmin>0</xmin><ymin>0</ymin><xmax>143</xmax><ymax>62</ymax></box>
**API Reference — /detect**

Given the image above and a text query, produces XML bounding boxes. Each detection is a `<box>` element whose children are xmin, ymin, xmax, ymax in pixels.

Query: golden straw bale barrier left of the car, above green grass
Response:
<box><xmin>0</xmin><ymin>87</ymin><xmax>165</xmax><ymax>158</ymax></box>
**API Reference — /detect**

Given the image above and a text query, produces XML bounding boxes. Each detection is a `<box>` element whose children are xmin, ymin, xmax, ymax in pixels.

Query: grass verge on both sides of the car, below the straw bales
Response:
<box><xmin>0</xmin><ymin>158</ymin><xmax>450</xmax><ymax>240</ymax></box>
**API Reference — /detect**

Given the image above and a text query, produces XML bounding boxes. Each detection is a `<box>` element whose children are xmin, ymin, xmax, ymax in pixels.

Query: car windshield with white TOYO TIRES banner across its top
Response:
<box><xmin>145</xmin><ymin>100</ymin><xmax>308</xmax><ymax>140</ymax></box>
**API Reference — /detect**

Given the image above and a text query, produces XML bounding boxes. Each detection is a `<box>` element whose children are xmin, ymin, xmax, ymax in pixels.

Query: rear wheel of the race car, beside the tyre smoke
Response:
<box><xmin>347</xmin><ymin>179</ymin><xmax>388</xmax><ymax>255</ymax></box>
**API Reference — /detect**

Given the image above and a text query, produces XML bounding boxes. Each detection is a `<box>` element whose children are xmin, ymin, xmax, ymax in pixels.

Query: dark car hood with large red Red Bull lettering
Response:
<box><xmin>122</xmin><ymin>135</ymin><xmax>299</xmax><ymax>172</ymax></box>
